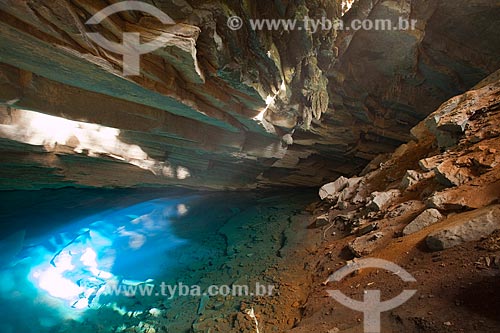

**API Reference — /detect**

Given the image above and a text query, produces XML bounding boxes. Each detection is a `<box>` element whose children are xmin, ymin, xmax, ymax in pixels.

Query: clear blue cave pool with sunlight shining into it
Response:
<box><xmin>0</xmin><ymin>189</ymin><xmax>311</xmax><ymax>333</ymax></box>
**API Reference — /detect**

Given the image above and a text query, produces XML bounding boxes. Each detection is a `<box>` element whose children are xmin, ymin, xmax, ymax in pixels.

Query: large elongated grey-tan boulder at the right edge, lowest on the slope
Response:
<box><xmin>426</xmin><ymin>205</ymin><xmax>500</xmax><ymax>251</ymax></box>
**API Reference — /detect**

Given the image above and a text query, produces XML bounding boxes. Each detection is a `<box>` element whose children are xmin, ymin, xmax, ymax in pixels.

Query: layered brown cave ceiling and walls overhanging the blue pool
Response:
<box><xmin>0</xmin><ymin>0</ymin><xmax>500</xmax><ymax>189</ymax></box>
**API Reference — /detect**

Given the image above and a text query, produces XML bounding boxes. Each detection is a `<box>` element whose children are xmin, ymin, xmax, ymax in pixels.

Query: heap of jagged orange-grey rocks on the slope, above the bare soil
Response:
<box><xmin>316</xmin><ymin>67</ymin><xmax>500</xmax><ymax>256</ymax></box>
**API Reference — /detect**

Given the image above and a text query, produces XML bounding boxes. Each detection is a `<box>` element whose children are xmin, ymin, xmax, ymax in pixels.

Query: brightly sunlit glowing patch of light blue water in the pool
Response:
<box><xmin>0</xmin><ymin>199</ymin><xmax>189</xmax><ymax>319</ymax></box>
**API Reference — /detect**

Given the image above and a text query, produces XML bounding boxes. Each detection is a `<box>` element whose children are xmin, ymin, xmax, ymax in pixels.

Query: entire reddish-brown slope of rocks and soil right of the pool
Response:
<box><xmin>284</xmin><ymin>65</ymin><xmax>500</xmax><ymax>333</ymax></box>
